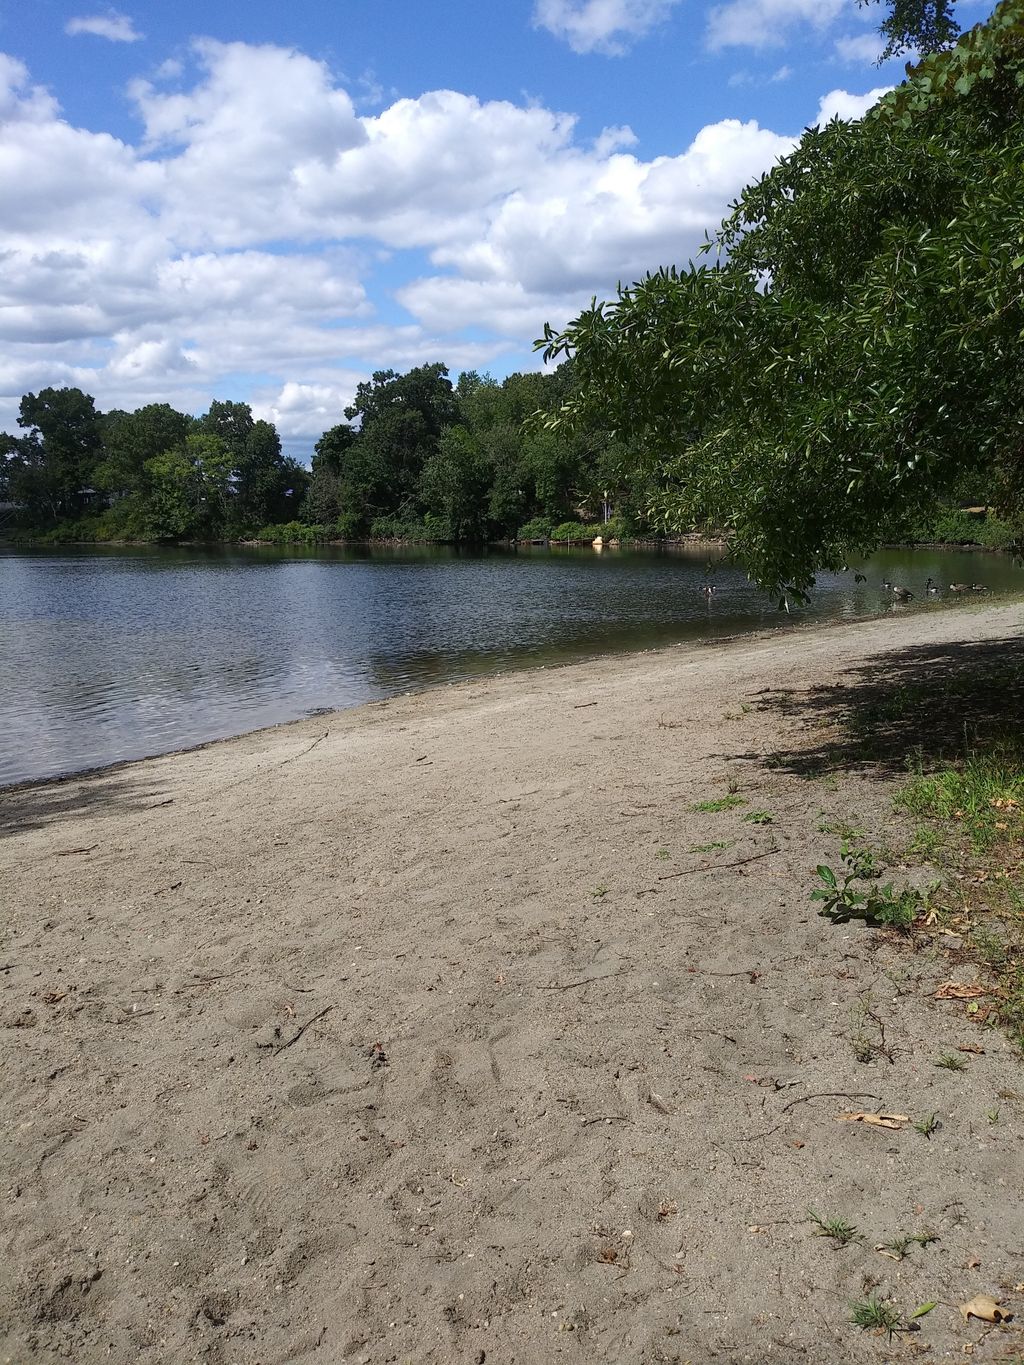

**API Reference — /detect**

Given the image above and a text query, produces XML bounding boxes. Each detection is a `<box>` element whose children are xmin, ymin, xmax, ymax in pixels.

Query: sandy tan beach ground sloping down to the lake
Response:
<box><xmin>0</xmin><ymin>605</ymin><xmax>1024</xmax><ymax>1365</ymax></box>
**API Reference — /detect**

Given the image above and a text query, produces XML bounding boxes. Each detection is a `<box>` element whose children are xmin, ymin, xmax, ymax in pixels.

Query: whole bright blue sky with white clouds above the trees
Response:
<box><xmin>0</xmin><ymin>0</ymin><xmax>984</xmax><ymax>455</ymax></box>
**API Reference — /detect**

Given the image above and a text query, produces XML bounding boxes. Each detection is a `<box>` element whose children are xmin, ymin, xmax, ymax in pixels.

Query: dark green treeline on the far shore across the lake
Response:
<box><xmin>0</xmin><ymin>363</ymin><xmax>650</xmax><ymax>543</ymax></box>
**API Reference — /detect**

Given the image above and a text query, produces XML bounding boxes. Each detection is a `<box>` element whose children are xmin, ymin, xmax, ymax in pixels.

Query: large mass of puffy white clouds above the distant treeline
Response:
<box><xmin>0</xmin><ymin>41</ymin><xmax>875</xmax><ymax>442</ymax></box>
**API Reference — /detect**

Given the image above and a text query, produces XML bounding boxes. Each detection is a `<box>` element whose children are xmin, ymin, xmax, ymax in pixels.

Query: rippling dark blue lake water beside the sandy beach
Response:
<box><xmin>0</xmin><ymin>537</ymin><xmax>1024</xmax><ymax>785</ymax></box>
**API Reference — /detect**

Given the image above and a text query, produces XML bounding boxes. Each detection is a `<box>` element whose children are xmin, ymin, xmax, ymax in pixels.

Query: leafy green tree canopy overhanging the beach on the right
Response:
<box><xmin>538</xmin><ymin>0</ymin><xmax>1024</xmax><ymax>597</ymax></box>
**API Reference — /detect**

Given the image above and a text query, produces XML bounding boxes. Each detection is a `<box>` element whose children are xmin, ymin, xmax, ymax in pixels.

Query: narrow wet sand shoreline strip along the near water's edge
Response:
<box><xmin>0</xmin><ymin>589</ymin><xmax>1024</xmax><ymax>797</ymax></box>
